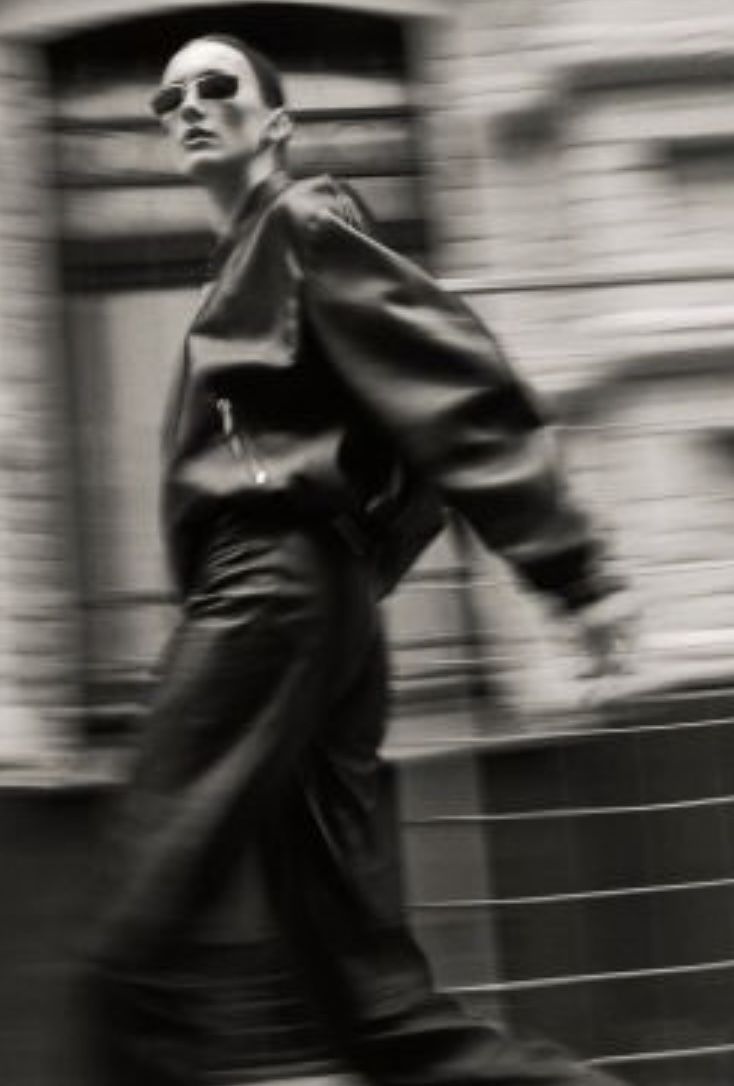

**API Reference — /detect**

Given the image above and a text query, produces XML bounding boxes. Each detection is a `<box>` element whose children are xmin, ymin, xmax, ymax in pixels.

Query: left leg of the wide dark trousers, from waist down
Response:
<box><xmin>84</xmin><ymin>523</ymin><xmax>375</xmax><ymax>1086</ymax></box>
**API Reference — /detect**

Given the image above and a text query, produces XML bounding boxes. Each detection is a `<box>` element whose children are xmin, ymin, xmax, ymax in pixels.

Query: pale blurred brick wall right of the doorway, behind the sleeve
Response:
<box><xmin>415</xmin><ymin>0</ymin><xmax>734</xmax><ymax>708</ymax></box>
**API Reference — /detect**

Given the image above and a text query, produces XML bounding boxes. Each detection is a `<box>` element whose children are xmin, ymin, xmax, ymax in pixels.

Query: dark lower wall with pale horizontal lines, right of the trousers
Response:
<box><xmin>404</xmin><ymin>691</ymin><xmax>734</xmax><ymax>1086</ymax></box>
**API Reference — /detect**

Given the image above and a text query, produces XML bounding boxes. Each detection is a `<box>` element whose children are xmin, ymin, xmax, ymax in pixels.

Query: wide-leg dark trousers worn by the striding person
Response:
<box><xmin>86</xmin><ymin>520</ymin><xmax>625</xmax><ymax>1086</ymax></box>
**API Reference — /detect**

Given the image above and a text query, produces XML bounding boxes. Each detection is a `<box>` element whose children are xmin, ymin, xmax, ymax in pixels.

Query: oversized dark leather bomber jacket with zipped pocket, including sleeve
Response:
<box><xmin>162</xmin><ymin>173</ymin><xmax>608</xmax><ymax>606</ymax></box>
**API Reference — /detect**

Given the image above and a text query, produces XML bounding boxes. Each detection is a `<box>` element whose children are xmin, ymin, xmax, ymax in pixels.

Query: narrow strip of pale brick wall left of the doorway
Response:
<box><xmin>0</xmin><ymin>45</ymin><xmax>77</xmax><ymax>766</ymax></box>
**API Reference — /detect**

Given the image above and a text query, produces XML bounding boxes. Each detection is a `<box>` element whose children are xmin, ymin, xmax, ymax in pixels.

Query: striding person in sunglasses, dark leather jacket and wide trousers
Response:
<box><xmin>84</xmin><ymin>29</ymin><xmax>623</xmax><ymax>1086</ymax></box>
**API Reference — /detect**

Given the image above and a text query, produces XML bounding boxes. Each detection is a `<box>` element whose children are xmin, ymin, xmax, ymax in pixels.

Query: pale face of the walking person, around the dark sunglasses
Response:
<box><xmin>161</xmin><ymin>41</ymin><xmax>274</xmax><ymax>181</ymax></box>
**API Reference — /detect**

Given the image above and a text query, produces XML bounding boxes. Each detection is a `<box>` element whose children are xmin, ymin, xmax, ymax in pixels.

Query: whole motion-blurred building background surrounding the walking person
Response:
<box><xmin>0</xmin><ymin>0</ymin><xmax>734</xmax><ymax>1086</ymax></box>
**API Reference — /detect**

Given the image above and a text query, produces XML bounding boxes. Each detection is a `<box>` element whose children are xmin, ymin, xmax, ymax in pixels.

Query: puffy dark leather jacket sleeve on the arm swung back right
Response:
<box><xmin>303</xmin><ymin>198</ymin><xmax>617</xmax><ymax>607</ymax></box>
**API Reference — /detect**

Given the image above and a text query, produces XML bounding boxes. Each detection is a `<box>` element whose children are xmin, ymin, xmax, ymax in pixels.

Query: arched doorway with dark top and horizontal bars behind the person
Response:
<box><xmin>47</xmin><ymin>3</ymin><xmax>438</xmax><ymax>724</ymax></box>
